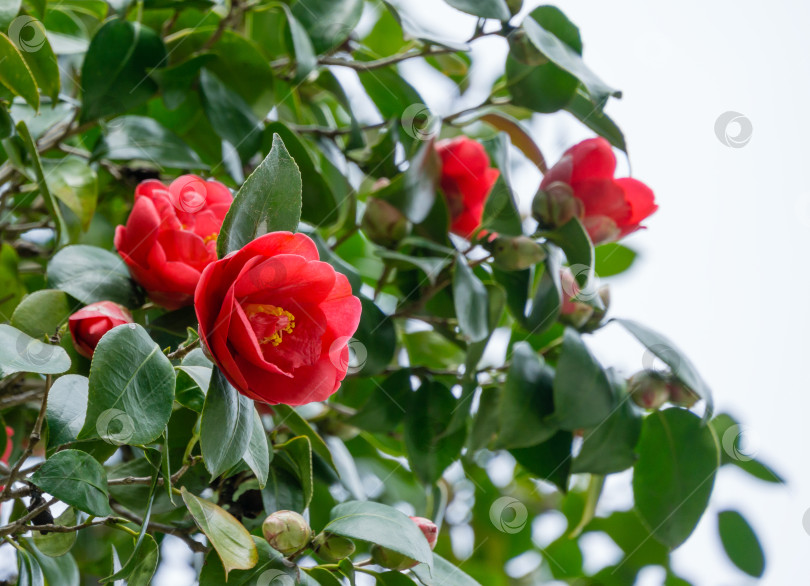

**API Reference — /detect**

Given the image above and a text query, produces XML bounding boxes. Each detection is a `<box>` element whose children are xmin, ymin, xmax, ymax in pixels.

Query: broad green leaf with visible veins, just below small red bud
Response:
<box><xmin>79</xmin><ymin>324</ymin><xmax>175</xmax><ymax>445</ymax></box>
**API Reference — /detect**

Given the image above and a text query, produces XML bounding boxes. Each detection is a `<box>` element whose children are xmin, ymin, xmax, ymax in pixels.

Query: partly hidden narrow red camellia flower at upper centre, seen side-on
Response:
<box><xmin>436</xmin><ymin>136</ymin><xmax>499</xmax><ymax>238</ymax></box>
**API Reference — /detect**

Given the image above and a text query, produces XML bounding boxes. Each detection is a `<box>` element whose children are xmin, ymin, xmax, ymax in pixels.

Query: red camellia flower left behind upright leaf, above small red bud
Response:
<box><xmin>115</xmin><ymin>175</ymin><xmax>233</xmax><ymax>309</ymax></box>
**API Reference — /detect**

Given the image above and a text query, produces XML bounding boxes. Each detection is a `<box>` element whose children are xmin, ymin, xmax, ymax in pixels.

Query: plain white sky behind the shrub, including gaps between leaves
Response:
<box><xmin>155</xmin><ymin>0</ymin><xmax>810</xmax><ymax>586</ymax></box>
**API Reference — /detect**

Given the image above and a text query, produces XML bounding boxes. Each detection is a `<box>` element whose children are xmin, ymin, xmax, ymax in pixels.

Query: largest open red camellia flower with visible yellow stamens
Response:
<box><xmin>194</xmin><ymin>232</ymin><xmax>360</xmax><ymax>405</ymax></box>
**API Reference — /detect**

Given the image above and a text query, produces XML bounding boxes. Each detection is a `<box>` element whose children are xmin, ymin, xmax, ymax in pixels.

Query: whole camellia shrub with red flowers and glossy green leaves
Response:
<box><xmin>0</xmin><ymin>0</ymin><xmax>781</xmax><ymax>586</ymax></box>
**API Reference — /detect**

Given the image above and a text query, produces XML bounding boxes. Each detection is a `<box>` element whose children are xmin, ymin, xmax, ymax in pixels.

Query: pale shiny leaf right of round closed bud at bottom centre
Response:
<box><xmin>323</xmin><ymin>501</ymin><xmax>433</xmax><ymax>567</ymax></box>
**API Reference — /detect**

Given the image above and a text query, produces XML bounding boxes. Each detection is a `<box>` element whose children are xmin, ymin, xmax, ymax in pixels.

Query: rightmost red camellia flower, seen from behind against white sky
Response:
<box><xmin>540</xmin><ymin>137</ymin><xmax>658</xmax><ymax>244</ymax></box>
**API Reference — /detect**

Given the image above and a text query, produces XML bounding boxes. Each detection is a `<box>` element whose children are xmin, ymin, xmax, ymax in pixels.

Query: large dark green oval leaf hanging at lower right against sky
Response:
<box><xmin>633</xmin><ymin>408</ymin><xmax>720</xmax><ymax>547</ymax></box>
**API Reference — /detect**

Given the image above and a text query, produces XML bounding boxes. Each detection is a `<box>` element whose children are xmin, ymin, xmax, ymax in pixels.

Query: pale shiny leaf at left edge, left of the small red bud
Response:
<box><xmin>0</xmin><ymin>324</ymin><xmax>70</xmax><ymax>377</ymax></box>
